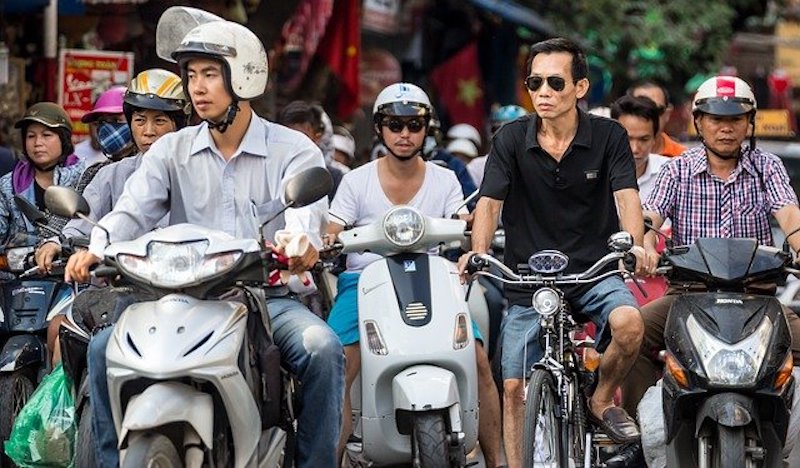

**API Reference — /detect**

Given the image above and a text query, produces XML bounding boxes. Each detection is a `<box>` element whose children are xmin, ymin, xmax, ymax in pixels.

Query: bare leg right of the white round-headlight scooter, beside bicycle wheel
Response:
<box><xmin>475</xmin><ymin>342</ymin><xmax>501</xmax><ymax>468</ymax></box>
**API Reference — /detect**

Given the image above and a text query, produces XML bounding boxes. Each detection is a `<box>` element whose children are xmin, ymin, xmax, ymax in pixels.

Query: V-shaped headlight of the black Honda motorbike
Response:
<box><xmin>686</xmin><ymin>315</ymin><xmax>772</xmax><ymax>386</ymax></box>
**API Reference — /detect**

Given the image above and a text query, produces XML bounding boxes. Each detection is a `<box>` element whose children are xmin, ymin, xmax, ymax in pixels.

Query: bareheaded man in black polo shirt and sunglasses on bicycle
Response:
<box><xmin>459</xmin><ymin>38</ymin><xmax>645</xmax><ymax>467</ymax></box>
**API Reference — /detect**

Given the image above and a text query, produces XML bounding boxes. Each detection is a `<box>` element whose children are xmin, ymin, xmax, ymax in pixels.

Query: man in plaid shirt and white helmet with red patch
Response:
<box><xmin>607</xmin><ymin>76</ymin><xmax>800</xmax><ymax>467</ymax></box>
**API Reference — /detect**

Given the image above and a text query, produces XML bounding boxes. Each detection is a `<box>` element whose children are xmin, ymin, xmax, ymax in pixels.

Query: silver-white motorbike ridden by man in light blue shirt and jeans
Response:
<box><xmin>45</xmin><ymin>168</ymin><xmax>330</xmax><ymax>468</ymax></box>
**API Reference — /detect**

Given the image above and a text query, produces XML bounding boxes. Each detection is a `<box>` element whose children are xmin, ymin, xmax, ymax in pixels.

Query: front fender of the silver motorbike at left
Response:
<box><xmin>119</xmin><ymin>382</ymin><xmax>214</xmax><ymax>449</ymax></box>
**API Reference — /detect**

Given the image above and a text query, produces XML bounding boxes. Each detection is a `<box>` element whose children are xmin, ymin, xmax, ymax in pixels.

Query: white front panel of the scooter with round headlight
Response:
<box><xmin>358</xmin><ymin>256</ymin><xmax>478</xmax><ymax>464</ymax></box>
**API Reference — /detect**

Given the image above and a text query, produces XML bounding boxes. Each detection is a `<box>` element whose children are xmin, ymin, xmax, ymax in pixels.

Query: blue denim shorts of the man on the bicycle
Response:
<box><xmin>500</xmin><ymin>276</ymin><xmax>639</xmax><ymax>379</ymax></box>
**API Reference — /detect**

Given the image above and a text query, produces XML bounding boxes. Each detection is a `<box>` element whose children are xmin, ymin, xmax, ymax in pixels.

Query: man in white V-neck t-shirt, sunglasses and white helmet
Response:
<box><xmin>326</xmin><ymin>83</ymin><xmax>500</xmax><ymax>467</ymax></box>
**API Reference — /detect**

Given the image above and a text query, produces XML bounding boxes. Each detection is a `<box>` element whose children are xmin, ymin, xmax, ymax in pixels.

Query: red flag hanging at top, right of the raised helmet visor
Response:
<box><xmin>318</xmin><ymin>0</ymin><xmax>361</xmax><ymax>119</ymax></box>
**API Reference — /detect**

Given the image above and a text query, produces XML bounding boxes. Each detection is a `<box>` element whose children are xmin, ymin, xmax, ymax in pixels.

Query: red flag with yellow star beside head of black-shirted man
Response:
<box><xmin>431</xmin><ymin>42</ymin><xmax>485</xmax><ymax>129</ymax></box>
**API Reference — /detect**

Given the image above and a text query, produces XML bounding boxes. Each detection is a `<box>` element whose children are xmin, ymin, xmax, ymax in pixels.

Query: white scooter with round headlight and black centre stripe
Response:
<box><xmin>339</xmin><ymin>206</ymin><xmax>478</xmax><ymax>468</ymax></box>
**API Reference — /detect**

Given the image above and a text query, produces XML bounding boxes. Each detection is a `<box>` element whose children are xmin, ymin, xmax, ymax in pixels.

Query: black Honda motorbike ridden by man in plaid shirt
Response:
<box><xmin>659</xmin><ymin>239</ymin><xmax>797</xmax><ymax>468</ymax></box>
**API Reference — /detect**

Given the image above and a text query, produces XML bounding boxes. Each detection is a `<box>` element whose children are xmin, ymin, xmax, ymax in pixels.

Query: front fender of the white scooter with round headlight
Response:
<box><xmin>392</xmin><ymin>365</ymin><xmax>459</xmax><ymax>411</ymax></box>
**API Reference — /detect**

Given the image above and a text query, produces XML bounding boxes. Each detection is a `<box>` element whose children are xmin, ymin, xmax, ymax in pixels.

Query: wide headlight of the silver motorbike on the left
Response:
<box><xmin>117</xmin><ymin>240</ymin><xmax>242</xmax><ymax>288</ymax></box>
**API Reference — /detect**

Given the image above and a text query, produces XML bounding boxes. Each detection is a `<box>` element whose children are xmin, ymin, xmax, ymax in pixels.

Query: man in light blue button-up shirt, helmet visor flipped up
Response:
<box><xmin>65</xmin><ymin>11</ymin><xmax>344</xmax><ymax>467</ymax></box>
